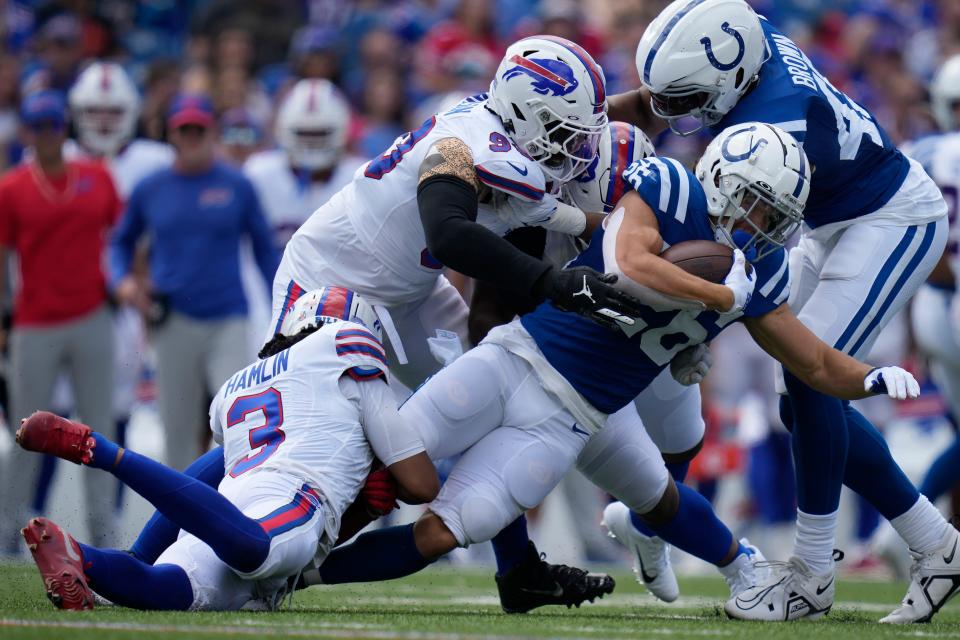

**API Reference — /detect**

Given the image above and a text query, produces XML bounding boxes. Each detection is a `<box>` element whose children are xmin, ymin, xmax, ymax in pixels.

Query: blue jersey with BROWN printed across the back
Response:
<box><xmin>710</xmin><ymin>19</ymin><xmax>910</xmax><ymax>228</ymax></box>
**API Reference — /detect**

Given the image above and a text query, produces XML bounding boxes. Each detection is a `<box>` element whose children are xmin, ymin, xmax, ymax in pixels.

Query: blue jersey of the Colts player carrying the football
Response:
<box><xmin>521</xmin><ymin>158</ymin><xmax>789</xmax><ymax>413</ymax></box>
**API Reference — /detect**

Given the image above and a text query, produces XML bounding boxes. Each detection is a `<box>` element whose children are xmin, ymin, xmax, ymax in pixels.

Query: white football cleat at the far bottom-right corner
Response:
<box><xmin>880</xmin><ymin>527</ymin><xmax>960</xmax><ymax>624</ymax></box>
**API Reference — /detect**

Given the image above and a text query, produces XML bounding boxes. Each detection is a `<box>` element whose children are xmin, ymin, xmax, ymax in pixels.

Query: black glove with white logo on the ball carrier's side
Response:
<box><xmin>537</xmin><ymin>267</ymin><xmax>643</xmax><ymax>329</ymax></box>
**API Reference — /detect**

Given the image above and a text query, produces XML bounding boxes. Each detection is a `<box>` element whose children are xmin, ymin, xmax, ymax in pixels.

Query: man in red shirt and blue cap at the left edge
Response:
<box><xmin>0</xmin><ymin>90</ymin><xmax>121</xmax><ymax>546</ymax></box>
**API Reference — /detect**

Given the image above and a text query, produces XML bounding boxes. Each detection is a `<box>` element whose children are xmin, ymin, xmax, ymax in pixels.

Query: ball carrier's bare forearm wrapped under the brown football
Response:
<box><xmin>617</xmin><ymin>246</ymin><xmax>733</xmax><ymax>311</ymax></box>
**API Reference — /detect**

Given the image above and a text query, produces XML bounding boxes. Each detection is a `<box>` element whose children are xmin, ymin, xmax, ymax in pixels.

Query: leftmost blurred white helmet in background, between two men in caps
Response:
<box><xmin>68</xmin><ymin>62</ymin><xmax>140</xmax><ymax>156</ymax></box>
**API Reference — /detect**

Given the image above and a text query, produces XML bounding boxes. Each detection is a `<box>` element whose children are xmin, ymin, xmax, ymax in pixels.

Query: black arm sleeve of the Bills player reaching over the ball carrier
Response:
<box><xmin>417</xmin><ymin>175</ymin><xmax>550</xmax><ymax>293</ymax></box>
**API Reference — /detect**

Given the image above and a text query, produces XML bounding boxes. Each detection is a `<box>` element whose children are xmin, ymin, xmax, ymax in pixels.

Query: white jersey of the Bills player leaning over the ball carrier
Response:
<box><xmin>284</xmin><ymin>94</ymin><xmax>557</xmax><ymax>306</ymax></box>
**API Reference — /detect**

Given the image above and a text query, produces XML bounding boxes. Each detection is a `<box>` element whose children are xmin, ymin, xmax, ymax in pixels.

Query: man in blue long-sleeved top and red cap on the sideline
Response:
<box><xmin>110</xmin><ymin>95</ymin><xmax>278</xmax><ymax>469</ymax></box>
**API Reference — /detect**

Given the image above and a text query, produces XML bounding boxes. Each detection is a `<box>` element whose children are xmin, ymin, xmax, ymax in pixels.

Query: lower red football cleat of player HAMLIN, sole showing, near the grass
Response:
<box><xmin>20</xmin><ymin>516</ymin><xmax>93</xmax><ymax>611</ymax></box>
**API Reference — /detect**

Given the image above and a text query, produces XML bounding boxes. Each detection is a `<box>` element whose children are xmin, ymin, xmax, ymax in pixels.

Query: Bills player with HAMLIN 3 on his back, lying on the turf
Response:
<box><xmin>17</xmin><ymin>287</ymin><xmax>439</xmax><ymax>610</ymax></box>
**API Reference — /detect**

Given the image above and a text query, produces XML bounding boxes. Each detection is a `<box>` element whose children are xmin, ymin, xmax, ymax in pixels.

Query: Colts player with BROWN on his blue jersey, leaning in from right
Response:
<box><xmin>610</xmin><ymin>0</ymin><xmax>960</xmax><ymax>623</ymax></box>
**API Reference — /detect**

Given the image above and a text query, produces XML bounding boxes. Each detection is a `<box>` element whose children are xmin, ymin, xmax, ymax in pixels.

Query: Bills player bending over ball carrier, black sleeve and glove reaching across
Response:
<box><xmin>268</xmin><ymin>36</ymin><xmax>631</xmax><ymax>387</ymax></box>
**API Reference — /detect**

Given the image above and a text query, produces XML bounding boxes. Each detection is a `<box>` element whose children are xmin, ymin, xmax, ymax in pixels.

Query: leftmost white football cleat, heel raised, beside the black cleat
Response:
<box><xmin>601</xmin><ymin>502</ymin><xmax>680</xmax><ymax>602</ymax></box>
